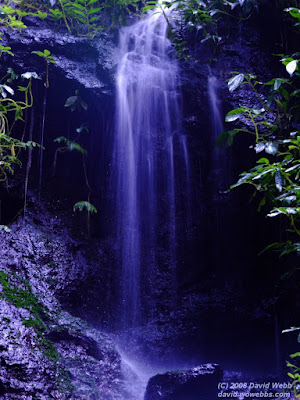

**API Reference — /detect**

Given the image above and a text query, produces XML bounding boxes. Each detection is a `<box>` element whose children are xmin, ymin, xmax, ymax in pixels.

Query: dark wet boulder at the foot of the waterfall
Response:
<box><xmin>144</xmin><ymin>364</ymin><xmax>223</xmax><ymax>400</ymax></box>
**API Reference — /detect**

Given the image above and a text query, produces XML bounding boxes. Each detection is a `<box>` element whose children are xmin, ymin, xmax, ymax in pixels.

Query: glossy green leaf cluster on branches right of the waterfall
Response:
<box><xmin>218</xmin><ymin>72</ymin><xmax>300</xmax><ymax>254</ymax></box>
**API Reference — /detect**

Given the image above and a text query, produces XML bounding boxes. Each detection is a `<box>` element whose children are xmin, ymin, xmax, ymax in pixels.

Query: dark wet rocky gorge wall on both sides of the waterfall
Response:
<box><xmin>0</xmin><ymin>7</ymin><xmax>299</xmax><ymax>400</ymax></box>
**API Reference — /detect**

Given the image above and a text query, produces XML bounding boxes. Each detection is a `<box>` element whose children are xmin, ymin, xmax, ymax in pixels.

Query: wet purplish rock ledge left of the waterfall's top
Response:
<box><xmin>3</xmin><ymin>18</ymin><xmax>117</xmax><ymax>94</ymax></box>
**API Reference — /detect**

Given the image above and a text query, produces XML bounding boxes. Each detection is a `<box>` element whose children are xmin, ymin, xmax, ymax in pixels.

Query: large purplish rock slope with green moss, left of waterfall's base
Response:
<box><xmin>0</xmin><ymin>204</ymin><xmax>123</xmax><ymax>400</ymax></box>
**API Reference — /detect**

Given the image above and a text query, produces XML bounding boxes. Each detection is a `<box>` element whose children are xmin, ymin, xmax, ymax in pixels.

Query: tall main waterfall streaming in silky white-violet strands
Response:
<box><xmin>111</xmin><ymin>6</ymin><xmax>189</xmax><ymax>326</ymax></box>
